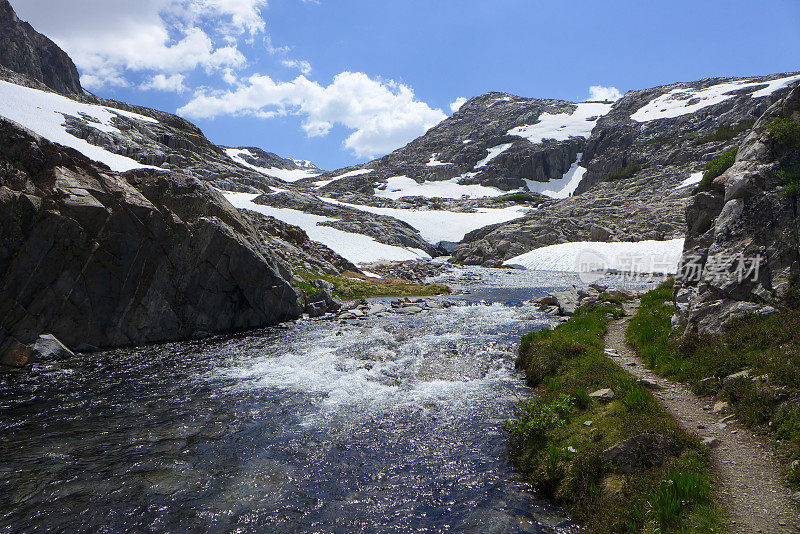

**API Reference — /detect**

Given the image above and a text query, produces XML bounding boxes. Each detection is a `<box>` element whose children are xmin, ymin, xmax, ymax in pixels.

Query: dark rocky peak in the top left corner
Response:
<box><xmin>0</xmin><ymin>0</ymin><xmax>83</xmax><ymax>94</ymax></box>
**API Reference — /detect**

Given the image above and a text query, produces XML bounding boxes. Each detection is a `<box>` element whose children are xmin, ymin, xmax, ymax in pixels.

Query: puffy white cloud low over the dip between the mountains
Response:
<box><xmin>178</xmin><ymin>72</ymin><xmax>446</xmax><ymax>157</ymax></box>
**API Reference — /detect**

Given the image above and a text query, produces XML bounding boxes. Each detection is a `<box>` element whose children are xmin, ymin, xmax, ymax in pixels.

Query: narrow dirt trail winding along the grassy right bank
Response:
<box><xmin>605</xmin><ymin>308</ymin><xmax>800</xmax><ymax>534</ymax></box>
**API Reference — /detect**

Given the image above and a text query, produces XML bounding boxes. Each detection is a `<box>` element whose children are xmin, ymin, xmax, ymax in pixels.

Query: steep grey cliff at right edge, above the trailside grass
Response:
<box><xmin>673</xmin><ymin>87</ymin><xmax>800</xmax><ymax>333</ymax></box>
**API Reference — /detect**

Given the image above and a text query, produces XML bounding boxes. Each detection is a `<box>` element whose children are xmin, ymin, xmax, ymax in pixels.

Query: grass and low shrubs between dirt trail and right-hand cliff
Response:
<box><xmin>626</xmin><ymin>282</ymin><xmax>800</xmax><ymax>488</ymax></box>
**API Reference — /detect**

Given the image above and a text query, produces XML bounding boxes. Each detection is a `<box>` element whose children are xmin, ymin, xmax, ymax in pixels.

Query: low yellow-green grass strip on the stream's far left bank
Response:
<box><xmin>295</xmin><ymin>269</ymin><xmax>451</xmax><ymax>300</ymax></box>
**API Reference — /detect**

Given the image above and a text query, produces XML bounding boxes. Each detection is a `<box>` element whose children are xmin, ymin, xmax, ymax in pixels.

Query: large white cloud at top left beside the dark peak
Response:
<box><xmin>14</xmin><ymin>0</ymin><xmax>266</xmax><ymax>88</ymax></box>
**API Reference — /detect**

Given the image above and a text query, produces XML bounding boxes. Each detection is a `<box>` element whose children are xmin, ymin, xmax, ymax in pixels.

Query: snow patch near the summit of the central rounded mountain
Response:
<box><xmin>508</xmin><ymin>102</ymin><xmax>613</xmax><ymax>144</ymax></box>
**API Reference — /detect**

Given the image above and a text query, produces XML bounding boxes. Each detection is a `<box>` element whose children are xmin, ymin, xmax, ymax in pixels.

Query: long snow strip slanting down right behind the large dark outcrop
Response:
<box><xmin>222</xmin><ymin>195</ymin><xmax>430</xmax><ymax>264</ymax></box>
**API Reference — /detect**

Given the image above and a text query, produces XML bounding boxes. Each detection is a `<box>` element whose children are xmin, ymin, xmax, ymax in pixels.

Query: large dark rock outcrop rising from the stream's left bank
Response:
<box><xmin>0</xmin><ymin>120</ymin><xmax>300</xmax><ymax>354</ymax></box>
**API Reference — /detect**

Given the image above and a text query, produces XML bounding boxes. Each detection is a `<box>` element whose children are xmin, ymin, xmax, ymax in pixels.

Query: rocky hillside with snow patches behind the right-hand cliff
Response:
<box><xmin>453</xmin><ymin>74</ymin><xmax>800</xmax><ymax>265</ymax></box>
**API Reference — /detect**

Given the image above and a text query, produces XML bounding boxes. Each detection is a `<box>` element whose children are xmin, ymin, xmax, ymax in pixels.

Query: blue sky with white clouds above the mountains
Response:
<box><xmin>10</xmin><ymin>0</ymin><xmax>800</xmax><ymax>169</ymax></box>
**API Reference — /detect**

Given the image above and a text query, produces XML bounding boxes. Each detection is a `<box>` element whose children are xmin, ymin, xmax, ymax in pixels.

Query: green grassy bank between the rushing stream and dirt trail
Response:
<box><xmin>506</xmin><ymin>303</ymin><xmax>722</xmax><ymax>533</ymax></box>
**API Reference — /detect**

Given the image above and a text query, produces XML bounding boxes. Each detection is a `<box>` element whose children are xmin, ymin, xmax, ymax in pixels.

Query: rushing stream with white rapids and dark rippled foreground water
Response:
<box><xmin>0</xmin><ymin>269</ymin><xmax>660</xmax><ymax>533</ymax></box>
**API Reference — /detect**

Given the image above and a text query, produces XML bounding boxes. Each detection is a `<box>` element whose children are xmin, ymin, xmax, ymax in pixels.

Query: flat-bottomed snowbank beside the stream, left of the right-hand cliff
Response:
<box><xmin>503</xmin><ymin>238</ymin><xmax>684</xmax><ymax>274</ymax></box>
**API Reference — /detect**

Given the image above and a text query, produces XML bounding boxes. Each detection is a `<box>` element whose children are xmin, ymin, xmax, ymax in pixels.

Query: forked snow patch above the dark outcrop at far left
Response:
<box><xmin>0</xmin><ymin>81</ymin><xmax>158</xmax><ymax>172</ymax></box>
